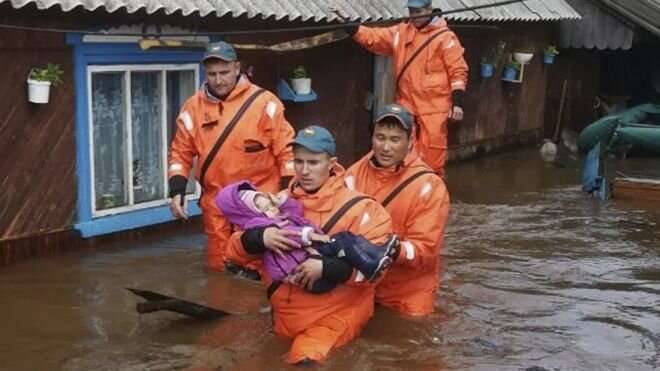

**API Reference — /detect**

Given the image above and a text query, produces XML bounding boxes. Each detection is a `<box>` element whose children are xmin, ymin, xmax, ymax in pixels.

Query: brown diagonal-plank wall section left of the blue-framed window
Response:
<box><xmin>0</xmin><ymin>29</ymin><xmax>76</xmax><ymax>240</ymax></box>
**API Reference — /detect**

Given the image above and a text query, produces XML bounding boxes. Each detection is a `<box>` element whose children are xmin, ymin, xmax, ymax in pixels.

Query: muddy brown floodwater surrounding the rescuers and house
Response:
<box><xmin>0</xmin><ymin>150</ymin><xmax>660</xmax><ymax>371</ymax></box>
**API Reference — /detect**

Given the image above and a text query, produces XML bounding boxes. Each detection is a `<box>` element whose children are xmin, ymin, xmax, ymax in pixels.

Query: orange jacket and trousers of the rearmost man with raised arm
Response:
<box><xmin>353</xmin><ymin>17</ymin><xmax>468</xmax><ymax>176</ymax></box>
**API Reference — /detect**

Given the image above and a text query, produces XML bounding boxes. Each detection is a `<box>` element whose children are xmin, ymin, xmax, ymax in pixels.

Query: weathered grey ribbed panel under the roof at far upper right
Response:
<box><xmin>559</xmin><ymin>0</ymin><xmax>635</xmax><ymax>50</ymax></box>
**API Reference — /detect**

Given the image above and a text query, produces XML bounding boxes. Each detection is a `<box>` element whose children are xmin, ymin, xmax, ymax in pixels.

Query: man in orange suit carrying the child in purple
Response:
<box><xmin>228</xmin><ymin>126</ymin><xmax>392</xmax><ymax>364</ymax></box>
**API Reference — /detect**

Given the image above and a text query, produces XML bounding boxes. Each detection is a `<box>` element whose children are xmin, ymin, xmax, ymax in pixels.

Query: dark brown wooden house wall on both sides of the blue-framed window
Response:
<box><xmin>0</xmin><ymin>4</ymin><xmax>372</xmax><ymax>265</ymax></box>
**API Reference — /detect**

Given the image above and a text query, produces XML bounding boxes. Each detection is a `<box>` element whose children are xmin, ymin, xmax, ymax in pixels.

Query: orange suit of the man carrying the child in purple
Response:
<box><xmin>228</xmin><ymin>166</ymin><xmax>392</xmax><ymax>364</ymax></box>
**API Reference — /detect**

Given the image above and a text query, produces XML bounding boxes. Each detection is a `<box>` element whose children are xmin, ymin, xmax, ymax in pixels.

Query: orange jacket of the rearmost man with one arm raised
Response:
<box><xmin>353</xmin><ymin>17</ymin><xmax>468</xmax><ymax>116</ymax></box>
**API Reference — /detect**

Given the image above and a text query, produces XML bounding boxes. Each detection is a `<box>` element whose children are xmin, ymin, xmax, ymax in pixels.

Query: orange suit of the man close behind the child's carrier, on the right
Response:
<box><xmin>345</xmin><ymin>151</ymin><xmax>449</xmax><ymax>315</ymax></box>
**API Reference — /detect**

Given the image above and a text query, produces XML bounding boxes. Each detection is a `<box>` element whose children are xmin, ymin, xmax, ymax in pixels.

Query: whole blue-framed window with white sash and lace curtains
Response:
<box><xmin>67</xmin><ymin>34</ymin><xmax>203</xmax><ymax>237</ymax></box>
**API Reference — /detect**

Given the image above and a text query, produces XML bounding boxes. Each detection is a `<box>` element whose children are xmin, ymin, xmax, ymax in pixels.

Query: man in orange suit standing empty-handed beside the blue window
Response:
<box><xmin>168</xmin><ymin>41</ymin><xmax>294</xmax><ymax>270</ymax></box>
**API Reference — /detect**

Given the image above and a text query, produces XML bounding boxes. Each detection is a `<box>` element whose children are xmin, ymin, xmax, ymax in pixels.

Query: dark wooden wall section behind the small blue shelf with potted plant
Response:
<box><xmin>229</xmin><ymin>40</ymin><xmax>373</xmax><ymax>166</ymax></box>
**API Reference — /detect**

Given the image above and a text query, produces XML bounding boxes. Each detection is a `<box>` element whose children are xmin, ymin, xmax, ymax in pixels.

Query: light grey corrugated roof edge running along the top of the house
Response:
<box><xmin>0</xmin><ymin>0</ymin><xmax>580</xmax><ymax>22</ymax></box>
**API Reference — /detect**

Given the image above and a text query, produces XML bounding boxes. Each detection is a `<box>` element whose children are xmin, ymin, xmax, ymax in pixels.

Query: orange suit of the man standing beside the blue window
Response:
<box><xmin>168</xmin><ymin>76</ymin><xmax>294</xmax><ymax>270</ymax></box>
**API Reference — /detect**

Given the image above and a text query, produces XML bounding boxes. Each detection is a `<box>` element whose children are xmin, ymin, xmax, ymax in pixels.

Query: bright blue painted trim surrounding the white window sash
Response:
<box><xmin>66</xmin><ymin>33</ymin><xmax>204</xmax><ymax>237</ymax></box>
